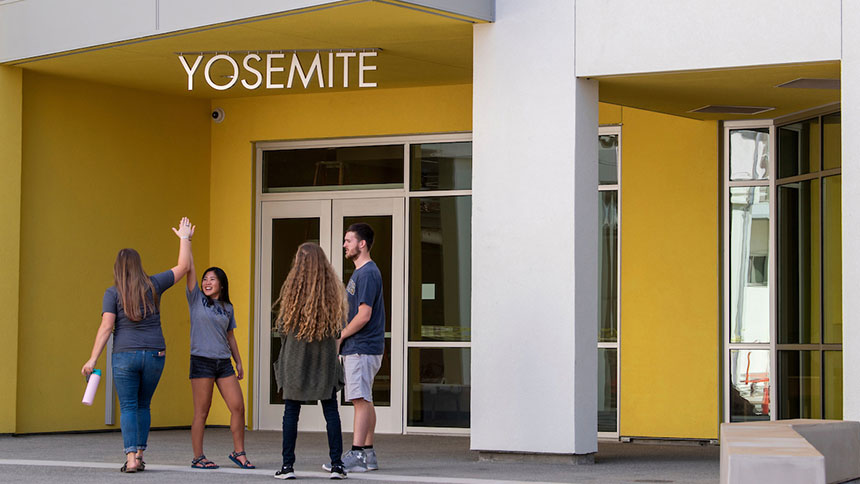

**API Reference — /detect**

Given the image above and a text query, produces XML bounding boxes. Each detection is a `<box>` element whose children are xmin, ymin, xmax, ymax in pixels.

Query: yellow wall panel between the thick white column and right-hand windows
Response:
<box><xmin>616</xmin><ymin>108</ymin><xmax>721</xmax><ymax>439</ymax></box>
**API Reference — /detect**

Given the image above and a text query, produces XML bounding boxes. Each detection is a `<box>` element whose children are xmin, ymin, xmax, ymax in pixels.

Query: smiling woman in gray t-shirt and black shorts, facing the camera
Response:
<box><xmin>185</xmin><ymin>251</ymin><xmax>254</xmax><ymax>469</ymax></box>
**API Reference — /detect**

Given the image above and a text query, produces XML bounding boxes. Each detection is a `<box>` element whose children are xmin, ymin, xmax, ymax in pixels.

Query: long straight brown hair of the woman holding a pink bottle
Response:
<box><xmin>113</xmin><ymin>249</ymin><xmax>159</xmax><ymax>321</ymax></box>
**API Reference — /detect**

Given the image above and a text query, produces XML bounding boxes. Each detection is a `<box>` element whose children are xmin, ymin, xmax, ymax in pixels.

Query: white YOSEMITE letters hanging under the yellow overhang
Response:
<box><xmin>179</xmin><ymin>51</ymin><xmax>377</xmax><ymax>91</ymax></box>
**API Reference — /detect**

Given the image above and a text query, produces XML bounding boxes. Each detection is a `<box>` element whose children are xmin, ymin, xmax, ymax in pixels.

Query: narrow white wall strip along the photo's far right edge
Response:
<box><xmin>842</xmin><ymin>0</ymin><xmax>860</xmax><ymax>420</ymax></box>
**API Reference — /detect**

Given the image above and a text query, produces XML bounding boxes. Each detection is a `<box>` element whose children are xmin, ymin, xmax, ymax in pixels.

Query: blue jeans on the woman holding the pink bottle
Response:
<box><xmin>111</xmin><ymin>350</ymin><xmax>164</xmax><ymax>454</ymax></box>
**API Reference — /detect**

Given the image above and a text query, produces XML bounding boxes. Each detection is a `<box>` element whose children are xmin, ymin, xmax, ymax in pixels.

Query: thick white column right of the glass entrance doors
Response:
<box><xmin>471</xmin><ymin>0</ymin><xmax>598</xmax><ymax>455</ymax></box>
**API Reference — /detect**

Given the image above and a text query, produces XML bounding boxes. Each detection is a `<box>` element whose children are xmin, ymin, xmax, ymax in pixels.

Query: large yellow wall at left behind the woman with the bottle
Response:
<box><xmin>19</xmin><ymin>72</ymin><xmax>211</xmax><ymax>433</ymax></box>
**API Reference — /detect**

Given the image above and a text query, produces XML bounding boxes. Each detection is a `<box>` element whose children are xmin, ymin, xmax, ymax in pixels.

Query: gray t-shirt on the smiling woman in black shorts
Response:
<box><xmin>185</xmin><ymin>283</ymin><xmax>236</xmax><ymax>359</ymax></box>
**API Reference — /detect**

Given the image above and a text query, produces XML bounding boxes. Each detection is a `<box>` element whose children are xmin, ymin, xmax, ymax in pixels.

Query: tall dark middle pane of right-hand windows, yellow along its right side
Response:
<box><xmin>776</xmin><ymin>179</ymin><xmax>821</xmax><ymax>343</ymax></box>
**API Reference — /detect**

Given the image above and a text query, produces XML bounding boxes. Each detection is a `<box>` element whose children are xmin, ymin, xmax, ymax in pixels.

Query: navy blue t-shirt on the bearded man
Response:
<box><xmin>340</xmin><ymin>261</ymin><xmax>385</xmax><ymax>355</ymax></box>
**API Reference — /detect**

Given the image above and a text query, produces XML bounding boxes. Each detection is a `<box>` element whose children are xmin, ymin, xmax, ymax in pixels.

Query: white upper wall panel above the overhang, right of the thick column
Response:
<box><xmin>576</xmin><ymin>0</ymin><xmax>841</xmax><ymax>76</ymax></box>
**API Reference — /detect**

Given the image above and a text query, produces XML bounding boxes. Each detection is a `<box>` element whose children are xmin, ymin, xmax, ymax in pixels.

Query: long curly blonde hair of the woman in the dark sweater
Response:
<box><xmin>275</xmin><ymin>242</ymin><xmax>348</xmax><ymax>342</ymax></box>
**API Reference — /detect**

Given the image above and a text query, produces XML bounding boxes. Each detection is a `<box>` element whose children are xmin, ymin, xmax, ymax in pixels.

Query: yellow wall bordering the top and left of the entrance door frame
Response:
<box><xmin>210</xmin><ymin>85</ymin><xmax>472</xmax><ymax>423</ymax></box>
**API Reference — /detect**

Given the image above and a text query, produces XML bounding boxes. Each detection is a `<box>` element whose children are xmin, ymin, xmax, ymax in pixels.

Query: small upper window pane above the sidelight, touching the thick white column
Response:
<box><xmin>409</xmin><ymin>141</ymin><xmax>472</xmax><ymax>190</ymax></box>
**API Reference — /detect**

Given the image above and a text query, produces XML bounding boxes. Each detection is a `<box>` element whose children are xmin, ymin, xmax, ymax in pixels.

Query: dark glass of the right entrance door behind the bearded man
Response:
<box><xmin>342</xmin><ymin>215</ymin><xmax>393</xmax><ymax>407</ymax></box>
